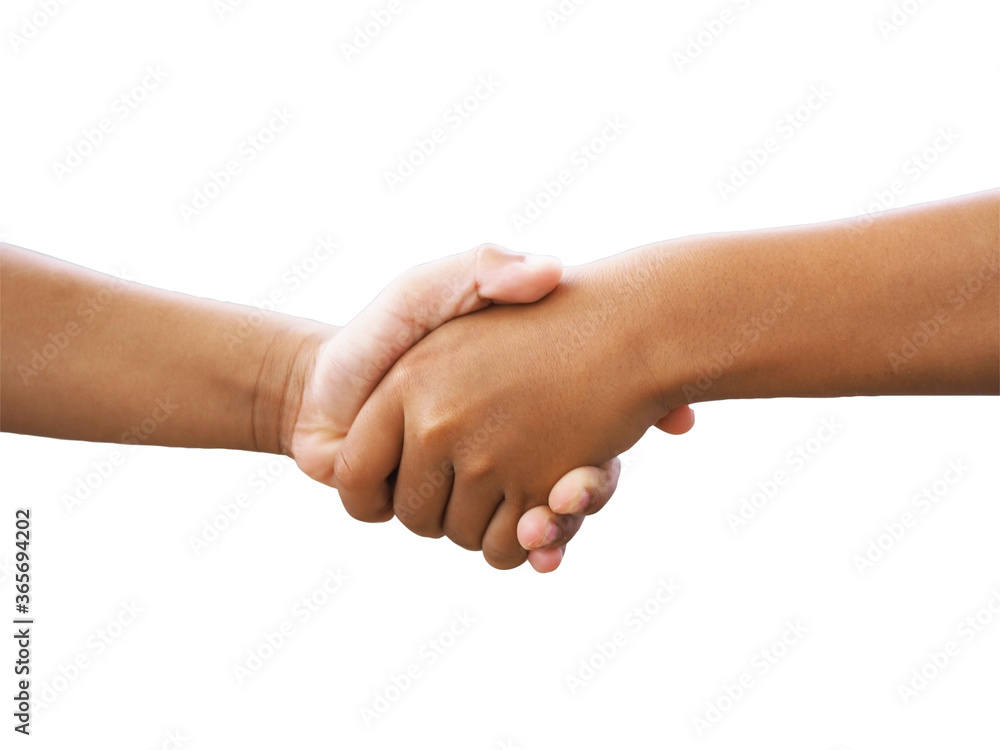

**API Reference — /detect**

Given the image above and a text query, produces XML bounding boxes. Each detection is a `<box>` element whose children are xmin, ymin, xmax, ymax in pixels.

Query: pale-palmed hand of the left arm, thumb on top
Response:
<box><xmin>285</xmin><ymin>245</ymin><xmax>632</xmax><ymax>564</ymax></box>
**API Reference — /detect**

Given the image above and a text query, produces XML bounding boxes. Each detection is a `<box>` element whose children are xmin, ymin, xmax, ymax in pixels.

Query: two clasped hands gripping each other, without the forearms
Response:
<box><xmin>283</xmin><ymin>245</ymin><xmax>693</xmax><ymax>572</ymax></box>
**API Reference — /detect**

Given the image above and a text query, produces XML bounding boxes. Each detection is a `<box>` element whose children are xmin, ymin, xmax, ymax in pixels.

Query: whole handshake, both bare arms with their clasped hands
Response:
<box><xmin>0</xmin><ymin>191</ymin><xmax>1000</xmax><ymax>572</ymax></box>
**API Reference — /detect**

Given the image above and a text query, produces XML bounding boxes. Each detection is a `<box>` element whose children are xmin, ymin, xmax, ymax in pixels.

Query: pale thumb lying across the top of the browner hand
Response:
<box><xmin>330</xmin><ymin>245</ymin><xmax>562</xmax><ymax>424</ymax></box>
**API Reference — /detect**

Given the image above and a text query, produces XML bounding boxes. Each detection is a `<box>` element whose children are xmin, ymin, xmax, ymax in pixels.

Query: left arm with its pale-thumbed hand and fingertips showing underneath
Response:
<box><xmin>0</xmin><ymin>245</ymin><xmax>692</xmax><ymax>570</ymax></box>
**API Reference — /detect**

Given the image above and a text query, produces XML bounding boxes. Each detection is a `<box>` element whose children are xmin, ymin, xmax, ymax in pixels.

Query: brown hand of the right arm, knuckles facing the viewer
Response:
<box><xmin>336</xmin><ymin>253</ymin><xmax>684</xmax><ymax>568</ymax></box>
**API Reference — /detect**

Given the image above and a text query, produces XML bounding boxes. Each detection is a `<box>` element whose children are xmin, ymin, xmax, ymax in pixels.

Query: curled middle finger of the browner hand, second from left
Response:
<box><xmin>392</xmin><ymin>438</ymin><xmax>455</xmax><ymax>539</ymax></box>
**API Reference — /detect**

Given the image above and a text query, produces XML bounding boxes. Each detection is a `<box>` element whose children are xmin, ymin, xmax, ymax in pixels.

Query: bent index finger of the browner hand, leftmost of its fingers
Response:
<box><xmin>333</xmin><ymin>388</ymin><xmax>404</xmax><ymax>522</ymax></box>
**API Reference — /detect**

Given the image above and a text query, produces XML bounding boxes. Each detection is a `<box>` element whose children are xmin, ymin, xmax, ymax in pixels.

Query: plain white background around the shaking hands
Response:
<box><xmin>0</xmin><ymin>0</ymin><xmax>1000</xmax><ymax>750</ymax></box>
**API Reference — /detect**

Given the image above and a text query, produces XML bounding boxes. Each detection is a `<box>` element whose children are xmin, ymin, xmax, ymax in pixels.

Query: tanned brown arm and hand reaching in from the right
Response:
<box><xmin>336</xmin><ymin>191</ymin><xmax>1000</xmax><ymax>568</ymax></box>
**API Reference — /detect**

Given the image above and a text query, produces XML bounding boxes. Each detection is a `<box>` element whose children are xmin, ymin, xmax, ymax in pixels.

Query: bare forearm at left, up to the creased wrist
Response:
<box><xmin>0</xmin><ymin>245</ymin><xmax>334</xmax><ymax>452</ymax></box>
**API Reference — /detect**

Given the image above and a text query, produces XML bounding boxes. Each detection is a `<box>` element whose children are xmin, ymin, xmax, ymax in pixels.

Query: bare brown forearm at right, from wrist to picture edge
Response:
<box><xmin>633</xmin><ymin>191</ymin><xmax>1000</xmax><ymax>406</ymax></box>
